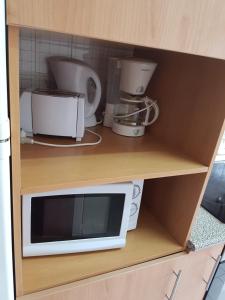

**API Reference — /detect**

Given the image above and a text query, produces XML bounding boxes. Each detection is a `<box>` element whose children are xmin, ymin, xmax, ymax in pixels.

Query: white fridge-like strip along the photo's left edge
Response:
<box><xmin>0</xmin><ymin>1</ymin><xmax>15</xmax><ymax>300</ymax></box>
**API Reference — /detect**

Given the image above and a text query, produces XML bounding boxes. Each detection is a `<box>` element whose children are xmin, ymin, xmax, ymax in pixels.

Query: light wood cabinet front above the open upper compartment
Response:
<box><xmin>7</xmin><ymin>0</ymin><xmax>225</xmax><ymax>59</ymax></box>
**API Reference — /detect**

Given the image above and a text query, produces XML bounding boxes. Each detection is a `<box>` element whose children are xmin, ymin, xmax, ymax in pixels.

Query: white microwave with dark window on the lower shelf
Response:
<box><xmin>22</xmin><ymin>180</ymin><xmax>143</xmax><ymax>257</ymax></box>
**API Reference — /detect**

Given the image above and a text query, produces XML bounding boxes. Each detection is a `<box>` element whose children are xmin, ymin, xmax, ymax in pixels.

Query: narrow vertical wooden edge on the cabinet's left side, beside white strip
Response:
<box><xmin>8</xmin><ymin>26</ymin><xmax>23</xmax><ymax>296</ymax></box>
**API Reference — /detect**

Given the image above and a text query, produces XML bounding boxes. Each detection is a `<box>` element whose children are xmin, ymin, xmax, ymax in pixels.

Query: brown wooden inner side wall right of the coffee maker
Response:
<box><xmin>135</xmin><ymin>49</ymin><xmax>225</xmax><ymax>166</ymax></box>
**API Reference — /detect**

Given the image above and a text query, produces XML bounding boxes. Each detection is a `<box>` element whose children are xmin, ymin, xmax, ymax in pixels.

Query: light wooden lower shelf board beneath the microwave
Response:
<box><xmin>23</xmin><ymin>209</ymin><xmax>184</xmax><ymax>294</ymax></box>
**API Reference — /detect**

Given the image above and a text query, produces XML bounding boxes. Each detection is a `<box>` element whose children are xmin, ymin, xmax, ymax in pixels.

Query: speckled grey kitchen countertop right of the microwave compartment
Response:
<box><xmin>190</xmin><ymin>207</ymin><xmax>225</xmax><ymax>250</ymax></box>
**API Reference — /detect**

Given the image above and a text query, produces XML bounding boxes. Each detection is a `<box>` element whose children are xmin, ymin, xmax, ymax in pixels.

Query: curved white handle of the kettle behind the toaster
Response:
<box><xmin>85</xmin><ymin>70</ymin><xmax>102</xmax><ymax>118</ymax></box>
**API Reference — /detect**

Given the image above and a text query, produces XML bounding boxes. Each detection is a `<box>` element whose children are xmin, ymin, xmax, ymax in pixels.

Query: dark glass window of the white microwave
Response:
<box><xmin>31</xmin><ymin>194</ymin><xmax>125</xmax><ymax>243</ymax></box>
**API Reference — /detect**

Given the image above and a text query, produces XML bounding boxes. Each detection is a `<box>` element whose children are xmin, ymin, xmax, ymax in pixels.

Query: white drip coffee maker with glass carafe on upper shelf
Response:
<box><xmin>104</xmin><ymin>58</ymin><xmax>159</xmax><ymax>137</ymax></box>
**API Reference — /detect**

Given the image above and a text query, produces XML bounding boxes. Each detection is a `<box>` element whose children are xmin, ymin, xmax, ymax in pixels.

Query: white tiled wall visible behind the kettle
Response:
<box><xmin>20</xmin><ymin>29</ymin><xmax>133</xmax><ymax>105</ymax></box>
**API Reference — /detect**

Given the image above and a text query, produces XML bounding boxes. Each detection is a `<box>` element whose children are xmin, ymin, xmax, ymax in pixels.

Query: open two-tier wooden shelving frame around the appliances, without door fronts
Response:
<box><xmin>8</xmin><ymin>24</ymin><xmax>225</xmax><ymax>296</ymax></box>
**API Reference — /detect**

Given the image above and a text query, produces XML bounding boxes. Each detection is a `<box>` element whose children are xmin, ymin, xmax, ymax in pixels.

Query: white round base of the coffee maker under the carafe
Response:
<box><xmin>112</xmin><ymin>121</ymin><xmax>145</xmax><ymax>137</ymax></box>
